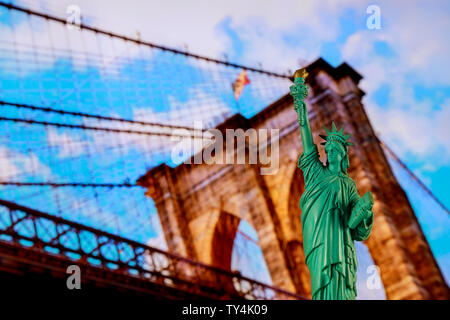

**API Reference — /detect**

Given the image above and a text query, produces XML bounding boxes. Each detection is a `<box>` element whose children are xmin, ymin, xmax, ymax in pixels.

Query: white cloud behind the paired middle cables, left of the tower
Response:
<box><xmin>43</xmin><ymin>87</ymin><xmax>231</xmax><ymax>158</ymax></box>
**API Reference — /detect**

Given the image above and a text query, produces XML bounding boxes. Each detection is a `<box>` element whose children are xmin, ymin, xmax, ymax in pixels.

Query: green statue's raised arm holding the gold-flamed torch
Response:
<box><xmin>290</xmin><ymin>68</ymin><xmax>314</xmax><ymax>154</ymax></box>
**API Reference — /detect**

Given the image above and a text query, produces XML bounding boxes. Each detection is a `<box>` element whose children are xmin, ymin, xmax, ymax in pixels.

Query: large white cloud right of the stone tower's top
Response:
<box><xmin>341</xmin><ymin>2</ymin><xmax>450</xmax><ymax>165</ymax></box>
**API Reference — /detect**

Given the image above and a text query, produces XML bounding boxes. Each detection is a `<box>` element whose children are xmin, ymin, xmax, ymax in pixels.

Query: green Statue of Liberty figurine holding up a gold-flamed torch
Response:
<box><xmin>290</xmin><ymin>69</ymin><xmax>373</xmax><ymax>300</ymax></box>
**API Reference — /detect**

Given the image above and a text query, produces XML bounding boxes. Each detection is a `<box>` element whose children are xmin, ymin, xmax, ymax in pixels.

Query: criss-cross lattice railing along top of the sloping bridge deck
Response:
<box><xmin>0</xmin><ymin>200</ymin><xmax>303</xmax><ymax>300</ymax></box>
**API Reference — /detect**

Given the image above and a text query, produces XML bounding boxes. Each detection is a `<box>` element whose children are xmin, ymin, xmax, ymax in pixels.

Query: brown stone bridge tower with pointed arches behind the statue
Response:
<box><xmin>138</xmin><ymin>59</ymin><xmax>449</xmax><ymax>299</ymax></box>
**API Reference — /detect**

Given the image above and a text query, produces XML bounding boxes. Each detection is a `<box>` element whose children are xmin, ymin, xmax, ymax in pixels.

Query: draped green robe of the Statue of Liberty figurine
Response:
<box><xmin>298</xmin><ymin>146</ymin><xmax>373</xmax><ymax>300</ymax></box>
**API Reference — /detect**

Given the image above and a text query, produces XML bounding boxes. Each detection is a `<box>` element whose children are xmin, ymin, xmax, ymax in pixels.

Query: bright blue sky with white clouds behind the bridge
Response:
<box><xmin>0</xmin><ymin>1</ymin><xmax>450</xmax><ymax>298</ymax></box>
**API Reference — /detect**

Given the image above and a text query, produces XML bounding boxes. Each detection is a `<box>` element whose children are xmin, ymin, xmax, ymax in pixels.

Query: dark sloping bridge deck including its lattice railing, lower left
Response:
<box><xmin>0</xmin><ymin>200</ymin><xmax>303</xmax><ymax>299</ymax></box>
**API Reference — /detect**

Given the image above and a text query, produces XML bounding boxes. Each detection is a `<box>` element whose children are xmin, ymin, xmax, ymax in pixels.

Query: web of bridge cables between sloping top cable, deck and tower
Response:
<box><xmin>0</xmin><ymin>2</ymin><xmax>291</xmax><ymax>290</ymax></box>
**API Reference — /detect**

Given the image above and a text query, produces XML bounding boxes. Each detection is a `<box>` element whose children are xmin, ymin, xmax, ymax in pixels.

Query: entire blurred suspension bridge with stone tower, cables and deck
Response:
<box><xmin>0</xmin><ymin>3</ymin><xmax>449</xmax><ymax>299</ymax></box>
